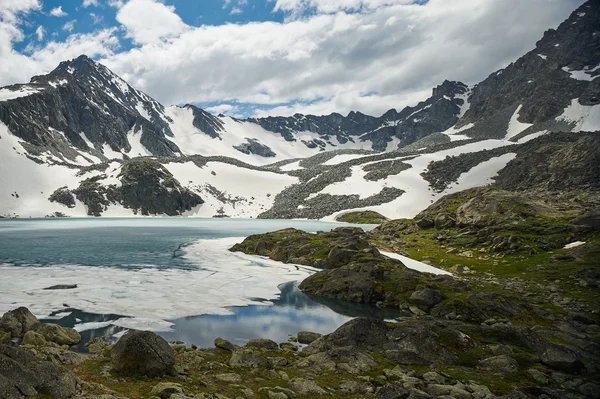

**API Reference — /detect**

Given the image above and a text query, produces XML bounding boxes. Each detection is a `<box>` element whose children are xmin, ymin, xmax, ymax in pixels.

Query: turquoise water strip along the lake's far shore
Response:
<box><xmin>0</xmin><ymin>218</ymin><xmax>360</xmax><ymax>268</ymax></box>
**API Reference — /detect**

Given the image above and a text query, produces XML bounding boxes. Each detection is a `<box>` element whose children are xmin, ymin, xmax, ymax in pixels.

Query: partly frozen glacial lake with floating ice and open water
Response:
<box><xmin>0</xmin><ymin>218</ymin><xmax>394</xmax><ymax>347</ymax></box>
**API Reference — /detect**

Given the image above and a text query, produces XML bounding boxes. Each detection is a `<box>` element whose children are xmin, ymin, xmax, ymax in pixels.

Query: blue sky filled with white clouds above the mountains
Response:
<box><xmin>0</xmin><ymin>0</ymin><xmax>584</xmax><ymax>117</ymax></box>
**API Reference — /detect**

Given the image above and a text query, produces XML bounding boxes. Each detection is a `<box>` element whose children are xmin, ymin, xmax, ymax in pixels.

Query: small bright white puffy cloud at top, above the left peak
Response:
<box><xmin>117</xmin><ymin>0</ymin><xmax>188</xmax><ymax>44</ymax></box>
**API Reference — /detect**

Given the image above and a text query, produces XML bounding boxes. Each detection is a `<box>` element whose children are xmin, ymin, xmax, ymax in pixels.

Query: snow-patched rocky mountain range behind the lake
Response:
<box><xmin>0</xmin><ymin>0</ymin><xmax>600</xmax><ymax>219</ymax></box>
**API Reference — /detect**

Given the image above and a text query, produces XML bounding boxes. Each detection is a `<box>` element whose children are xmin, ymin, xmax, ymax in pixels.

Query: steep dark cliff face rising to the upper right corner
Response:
<box><xmin>461</xmin><ymin>0</ymin><xmax>600</xmax><ymax>125</ymax></box>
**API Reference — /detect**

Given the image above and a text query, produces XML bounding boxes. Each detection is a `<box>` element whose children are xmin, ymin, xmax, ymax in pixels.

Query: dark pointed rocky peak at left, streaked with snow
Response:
<box><xmin>0</xmin><ymin>56</ymin><xmax>179</xmax><ymax>161</ymax></box>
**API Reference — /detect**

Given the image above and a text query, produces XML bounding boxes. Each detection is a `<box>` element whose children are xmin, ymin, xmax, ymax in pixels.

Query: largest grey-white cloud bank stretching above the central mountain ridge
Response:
<box><xmin>105</xmin><ymin>0</ymin><xmax>582</xmax><ymax>114</ymax></box>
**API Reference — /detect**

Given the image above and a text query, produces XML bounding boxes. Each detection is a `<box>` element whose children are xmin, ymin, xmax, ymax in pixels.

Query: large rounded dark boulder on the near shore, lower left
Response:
<box><xmin>111</xmin><ymin>331</ymin><xmax>175</xmax><ymax>377</ymax></box>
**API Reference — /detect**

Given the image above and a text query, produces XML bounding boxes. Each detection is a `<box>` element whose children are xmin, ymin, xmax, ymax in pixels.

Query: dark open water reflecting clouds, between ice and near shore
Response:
<box><xmin>43</xmin><ymin>282</ymin><xmax>398</xmax><ymax>347</ymax></box>
